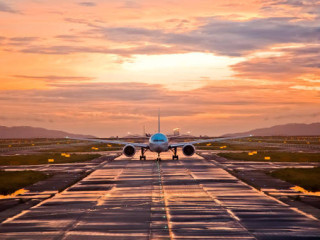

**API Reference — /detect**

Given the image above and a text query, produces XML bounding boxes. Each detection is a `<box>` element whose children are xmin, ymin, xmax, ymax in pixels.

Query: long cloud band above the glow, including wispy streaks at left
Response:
<box><xmin>20</xmin><ymin>17</ymin><xmax>320</xmax><ymax>56</ymax></box>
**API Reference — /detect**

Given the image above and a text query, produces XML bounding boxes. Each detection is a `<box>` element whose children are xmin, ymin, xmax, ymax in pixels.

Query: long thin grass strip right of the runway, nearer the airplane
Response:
<box><xmin>218</xmin><ymin>151</ymin><xmax>320</xmax><ymax>162</ymax></box>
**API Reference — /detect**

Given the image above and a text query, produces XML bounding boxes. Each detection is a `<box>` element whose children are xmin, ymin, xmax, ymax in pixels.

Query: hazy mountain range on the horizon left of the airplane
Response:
<box><xmin>0</xmin><ymin>126</ymin><xmax>94</xmax><ymax>139</ymax></box>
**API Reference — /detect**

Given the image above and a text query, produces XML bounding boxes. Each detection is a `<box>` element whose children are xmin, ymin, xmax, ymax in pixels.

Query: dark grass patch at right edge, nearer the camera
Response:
<box><xmin>269</xmin><ymin>167</ymin><xmax>320</xmax><ymax>192</ymax></box>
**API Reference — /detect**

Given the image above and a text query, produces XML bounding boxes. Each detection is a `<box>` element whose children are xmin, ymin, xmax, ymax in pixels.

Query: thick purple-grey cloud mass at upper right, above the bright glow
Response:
<box><xmin>167</xmin><ymin>18</ymin><xmax>319</xmax><ymax>56</ymax></box>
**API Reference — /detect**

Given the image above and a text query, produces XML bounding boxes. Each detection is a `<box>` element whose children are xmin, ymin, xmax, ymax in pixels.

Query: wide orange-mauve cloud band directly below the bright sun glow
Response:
<box><xmin>1</xmin><ymin>80</ymin><xmax>312</xmax><ymax>107</ymax></box>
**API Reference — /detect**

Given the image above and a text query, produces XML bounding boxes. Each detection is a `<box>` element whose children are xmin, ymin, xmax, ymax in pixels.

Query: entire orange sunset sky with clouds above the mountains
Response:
<box><xmin>0</xmin><ymin>0</ymin><xmax>320</xmax><ymax>137</ymax></box>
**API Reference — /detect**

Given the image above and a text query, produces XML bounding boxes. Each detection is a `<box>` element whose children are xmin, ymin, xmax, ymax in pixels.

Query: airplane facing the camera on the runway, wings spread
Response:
<box><xmin>66</xmin><ymin>111</ymin><xmax>252</xmax><ymax>161</ymax></box>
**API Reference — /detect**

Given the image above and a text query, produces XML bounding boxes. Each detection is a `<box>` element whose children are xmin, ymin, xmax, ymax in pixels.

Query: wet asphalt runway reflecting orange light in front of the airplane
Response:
<box><xmin>0</xmin><ymin>153</ymin><xmax>320</xmax><ymax>240</ymax></box>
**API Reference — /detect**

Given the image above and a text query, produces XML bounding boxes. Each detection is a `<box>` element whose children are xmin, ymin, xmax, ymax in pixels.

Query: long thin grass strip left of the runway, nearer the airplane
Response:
<box><xmin>0</xmin><ymin>153</ymin><xmax>101</xmax><ymax>165</ymax></box>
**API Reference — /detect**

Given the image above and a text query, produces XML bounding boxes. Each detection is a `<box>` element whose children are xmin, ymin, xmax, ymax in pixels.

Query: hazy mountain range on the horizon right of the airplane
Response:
<box><xmin>224</xmin><ymin>123</ymin><xmax>320</xmax><ymax>137</ymax></box>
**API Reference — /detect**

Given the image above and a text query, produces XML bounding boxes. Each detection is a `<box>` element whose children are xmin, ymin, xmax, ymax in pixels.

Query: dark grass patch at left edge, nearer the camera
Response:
<box><xmin>0</xmin><ymin>171</ymin><xmax>50</xmax><ymax>195</ymax></box>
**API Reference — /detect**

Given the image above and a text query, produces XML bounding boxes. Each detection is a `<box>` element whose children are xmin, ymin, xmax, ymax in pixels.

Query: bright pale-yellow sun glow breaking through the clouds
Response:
<box><xmin>122</xmin><ymin>52</ymin><xmax>242</xmax><ymax>90</ymax></box>
